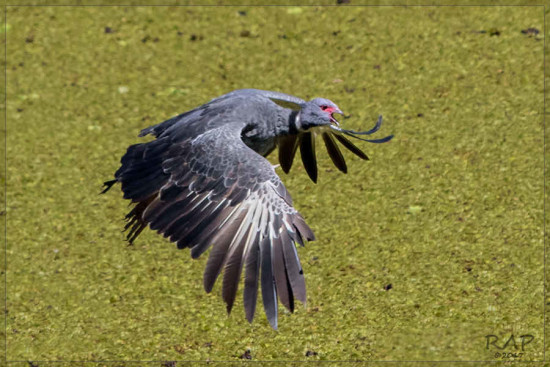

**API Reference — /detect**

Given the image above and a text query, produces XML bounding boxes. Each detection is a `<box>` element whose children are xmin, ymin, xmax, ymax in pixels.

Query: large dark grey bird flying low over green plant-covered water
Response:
<box><xmin>101</xmin><ymin>89</ymin><xmax>393</xmax><ymax>330</ymax></box>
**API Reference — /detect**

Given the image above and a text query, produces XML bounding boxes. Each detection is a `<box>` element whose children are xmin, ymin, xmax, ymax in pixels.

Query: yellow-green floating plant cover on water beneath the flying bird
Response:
<box><xmin>2</xmin><ymin>6</ymin><xmax>544</xmax><ymax>361</ymax></box>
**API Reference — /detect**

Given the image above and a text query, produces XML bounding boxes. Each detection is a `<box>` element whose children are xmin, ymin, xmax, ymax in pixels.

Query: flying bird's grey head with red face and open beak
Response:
<box><xmin>296</xmin><ymin>98</ymin><xmax>342</xmax><ymax>131</ymax></box>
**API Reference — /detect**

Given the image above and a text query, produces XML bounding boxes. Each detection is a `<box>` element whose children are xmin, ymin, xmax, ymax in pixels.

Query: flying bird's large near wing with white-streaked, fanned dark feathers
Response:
<box><xmin>112</xmin><ymin>122</ymin><xmax>314</xmax><ymax>328</ymax></box>
